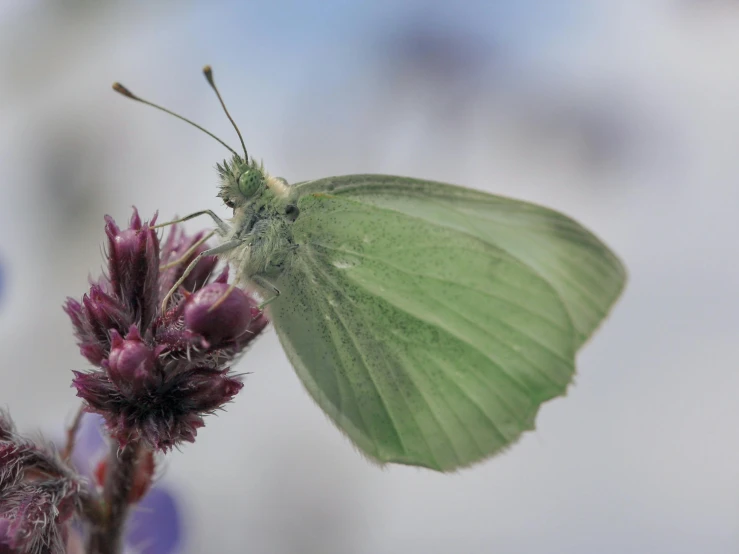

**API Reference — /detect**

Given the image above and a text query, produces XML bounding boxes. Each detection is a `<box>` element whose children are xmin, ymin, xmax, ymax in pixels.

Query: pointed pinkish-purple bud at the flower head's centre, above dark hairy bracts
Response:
<box><xmin>107</xmin><ymin>325</ymin><xmax>157</xmax><ymax>393</ymax></box>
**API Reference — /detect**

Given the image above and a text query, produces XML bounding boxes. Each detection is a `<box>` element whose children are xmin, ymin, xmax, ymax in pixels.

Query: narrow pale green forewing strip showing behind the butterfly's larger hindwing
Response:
<box><xmin>295</xmin><ymin>175</ymin><xmax>626</xmax><ymax>345</ymax></box>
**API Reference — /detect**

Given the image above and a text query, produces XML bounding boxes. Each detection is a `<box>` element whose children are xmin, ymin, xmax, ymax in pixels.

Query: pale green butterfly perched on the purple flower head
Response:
<box><xmin>114</xmin><ymin>67</ymin><xmax>626</xmax><ymax>471</ymax></box>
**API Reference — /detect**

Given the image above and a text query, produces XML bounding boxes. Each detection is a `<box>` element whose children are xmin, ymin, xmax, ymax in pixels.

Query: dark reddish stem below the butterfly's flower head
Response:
<box><xmin>87</xmin><ymin>442</ymin><xmax>140</xmax><ymax>554</ymax></box>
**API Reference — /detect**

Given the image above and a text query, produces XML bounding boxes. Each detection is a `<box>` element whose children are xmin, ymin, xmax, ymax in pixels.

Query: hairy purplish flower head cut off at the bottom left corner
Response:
<box><xmin>0</xmin><ymin>411</ymin><xmax>82</xmax><ymax>554</ymax></box>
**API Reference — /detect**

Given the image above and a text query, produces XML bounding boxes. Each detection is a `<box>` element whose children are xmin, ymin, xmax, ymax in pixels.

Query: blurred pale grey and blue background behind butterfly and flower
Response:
<box><xmin>0</xmin><ymin>0</ymin><xmax>739</xmax><ymax>554</ymax></box>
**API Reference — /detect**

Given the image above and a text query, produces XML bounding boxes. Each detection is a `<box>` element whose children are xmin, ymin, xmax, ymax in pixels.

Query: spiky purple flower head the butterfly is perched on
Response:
<box><xmin>65</xmin><ymin>210</ymin><xmax>267</xmax><ymax>451</ymax></box>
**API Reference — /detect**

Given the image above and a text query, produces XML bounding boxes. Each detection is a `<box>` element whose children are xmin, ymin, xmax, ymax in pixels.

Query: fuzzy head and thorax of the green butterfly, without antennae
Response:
<box><xmin>218</xmin><ymin>156</ymin><xmax>298</xmax><ymax>282</ymax></box>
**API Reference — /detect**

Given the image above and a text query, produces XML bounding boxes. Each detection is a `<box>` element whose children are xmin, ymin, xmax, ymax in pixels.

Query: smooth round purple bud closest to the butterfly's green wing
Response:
<box><xmin>184</xmin><ymin>283</ymin><xmax>261</xmax><ymax>345</ymax></box>
